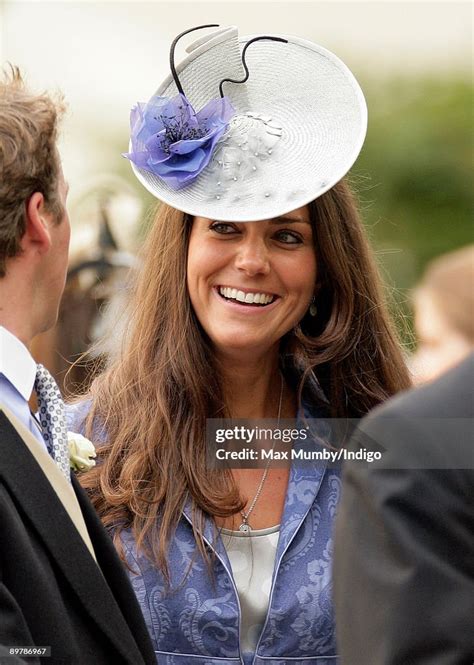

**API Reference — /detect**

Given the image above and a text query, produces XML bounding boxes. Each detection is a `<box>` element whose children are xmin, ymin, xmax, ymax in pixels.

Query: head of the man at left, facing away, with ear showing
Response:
<box><xmin>0</xmin><ymin>67</ymin><xmax>70</xmax><ymax>337</ymax></box>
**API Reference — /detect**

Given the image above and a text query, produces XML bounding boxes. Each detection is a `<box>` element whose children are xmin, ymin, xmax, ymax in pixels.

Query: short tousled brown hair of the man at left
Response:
<box><xmin>0</xmin><ymin>66</ymin><xmax>64</xmax><ymax>277</ymax></box>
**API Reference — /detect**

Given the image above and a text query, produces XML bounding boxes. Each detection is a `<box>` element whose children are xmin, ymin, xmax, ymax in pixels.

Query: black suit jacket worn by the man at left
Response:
<box><xmin>0</xmin><ymin>411</ymin><xmax>156</xmax><ymax>665</ymax></box>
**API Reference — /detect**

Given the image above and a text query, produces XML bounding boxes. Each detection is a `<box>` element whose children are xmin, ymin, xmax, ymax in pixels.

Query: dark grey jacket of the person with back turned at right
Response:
<box><xmin>334</xmin><ymin>356</ymin><xmax>474</xmax><ymax>665</ymax></box>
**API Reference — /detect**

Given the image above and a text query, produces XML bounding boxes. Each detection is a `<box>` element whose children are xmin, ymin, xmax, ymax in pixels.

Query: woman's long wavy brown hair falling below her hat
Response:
<box><xmin>83</xmin><ymin>182</ymin><xmax>409</xmax><ymax>581</ymax></box>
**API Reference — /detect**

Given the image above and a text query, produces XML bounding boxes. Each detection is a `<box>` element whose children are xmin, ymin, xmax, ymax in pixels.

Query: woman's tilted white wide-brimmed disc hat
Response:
<box><xmin>126</xmin><ymin>27</ymin><xmax>367</xmax><ymax>222</ymax></box>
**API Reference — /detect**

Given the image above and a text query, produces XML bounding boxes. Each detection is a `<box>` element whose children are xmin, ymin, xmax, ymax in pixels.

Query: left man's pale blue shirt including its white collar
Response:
<box><xmin>0</xmin><ymin>326</ymin><xmax>47</xmax><ymax>451</ymax></box>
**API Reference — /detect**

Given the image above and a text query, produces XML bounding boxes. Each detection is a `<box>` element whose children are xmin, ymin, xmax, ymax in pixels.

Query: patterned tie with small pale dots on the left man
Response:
<box><xmin>35</xmin><ymin>364</ymin><xmax>71</xmax><ymax>482</ymax></box>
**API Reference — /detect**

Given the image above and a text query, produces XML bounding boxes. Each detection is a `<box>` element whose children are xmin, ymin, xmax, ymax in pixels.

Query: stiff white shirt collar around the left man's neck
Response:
<box><xmin>0</xmin><ymin>326</ymin><xmax>36</xmax><ymax>401</ymax></box>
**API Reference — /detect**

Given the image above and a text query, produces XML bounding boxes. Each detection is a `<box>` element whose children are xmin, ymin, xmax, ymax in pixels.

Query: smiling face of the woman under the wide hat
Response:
<box><xmin>187</xmin><ymin>207</ymin><xmax>316</xmax><ymax>354</ymax></box>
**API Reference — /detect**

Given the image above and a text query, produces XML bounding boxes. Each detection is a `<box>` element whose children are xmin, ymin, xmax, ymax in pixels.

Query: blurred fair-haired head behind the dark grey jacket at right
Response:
<box><xmin>411</xmin><ymin>245</ymin><xmax>474</xmax><ymax>384</ymax></box>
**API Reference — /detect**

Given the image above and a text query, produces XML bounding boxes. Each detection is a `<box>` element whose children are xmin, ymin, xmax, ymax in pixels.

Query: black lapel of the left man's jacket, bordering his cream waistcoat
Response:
<box><xmin>0</xmin><ymin>410</ymin><xmax>148</xmax><ymax>663</ymax></box>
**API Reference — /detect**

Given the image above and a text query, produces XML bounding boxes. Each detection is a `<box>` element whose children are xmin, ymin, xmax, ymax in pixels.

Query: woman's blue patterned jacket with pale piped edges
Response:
<box><xmin>67</xmin><ymin>402</ymin><xmax>341</xmax><ymax>665</ymax></box>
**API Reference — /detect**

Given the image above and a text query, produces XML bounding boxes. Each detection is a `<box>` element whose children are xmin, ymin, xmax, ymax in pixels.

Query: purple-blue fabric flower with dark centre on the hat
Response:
<box><xmin>123</xmin><ymin>94</ymin><xmax>235</xmax><ymax>189</ymax></box>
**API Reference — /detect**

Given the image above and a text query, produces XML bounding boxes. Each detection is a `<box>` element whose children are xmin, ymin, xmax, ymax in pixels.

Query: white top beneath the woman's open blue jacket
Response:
<box><xmin>221</xmin><ymin>524</ymin><xmax>280</xmax><ymax>652</ymax></box>
